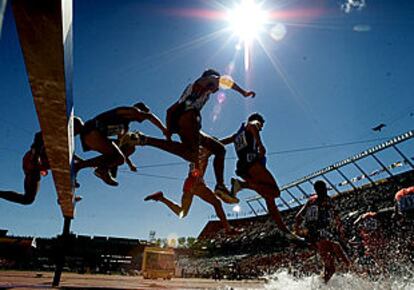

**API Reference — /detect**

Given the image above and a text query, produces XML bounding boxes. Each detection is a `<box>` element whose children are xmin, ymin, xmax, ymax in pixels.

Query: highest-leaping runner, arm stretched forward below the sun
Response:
<box><xmin>166</xmin><ymin>69</ymin><xmax>255</xmax><ymax>201</ymax></box>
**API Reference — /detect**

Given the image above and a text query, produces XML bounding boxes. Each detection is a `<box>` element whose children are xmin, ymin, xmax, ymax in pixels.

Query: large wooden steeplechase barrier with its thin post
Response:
<box><xmin>12</xmin><ymin>0</ymin><xmax>75</xmax><ymax>286</ymax></box>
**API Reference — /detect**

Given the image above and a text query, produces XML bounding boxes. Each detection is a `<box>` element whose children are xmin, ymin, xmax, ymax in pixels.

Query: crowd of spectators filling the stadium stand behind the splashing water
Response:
<box><xmin>178</xmin><ymin>171</ymin><xmax>414</xmax><ymax>279</ymax></box>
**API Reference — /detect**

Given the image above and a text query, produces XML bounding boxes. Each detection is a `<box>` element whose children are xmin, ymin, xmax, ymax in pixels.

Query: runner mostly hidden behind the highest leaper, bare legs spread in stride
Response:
<box><xmin>144</xmin><ymin>147</ymin><xmax>234</xmax><ymax>233</ymax></box>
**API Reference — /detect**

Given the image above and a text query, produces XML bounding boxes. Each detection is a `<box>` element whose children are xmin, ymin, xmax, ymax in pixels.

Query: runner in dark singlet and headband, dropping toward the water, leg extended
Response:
<box><xmin>220</xmin><ymin>113</ymin><xmax>301</xmax><ymax>240</ymax></box>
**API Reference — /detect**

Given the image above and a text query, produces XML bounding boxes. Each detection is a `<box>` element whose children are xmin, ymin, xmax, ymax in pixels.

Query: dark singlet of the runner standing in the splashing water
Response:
<box><xmin>304</xmin><ymin>195</ymin><xmax>335</xmax><ymax>237</ymax></box>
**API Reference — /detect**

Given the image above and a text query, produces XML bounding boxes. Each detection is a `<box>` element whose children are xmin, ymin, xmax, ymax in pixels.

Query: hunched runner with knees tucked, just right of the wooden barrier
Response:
<box><xmin>75</xmin><ymin>102</ymin><xmax>167</xmax><ymax>186</ymax></box>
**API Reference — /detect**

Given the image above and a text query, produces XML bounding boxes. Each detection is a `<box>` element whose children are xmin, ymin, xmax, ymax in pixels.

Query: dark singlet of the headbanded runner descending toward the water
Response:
<box><xmin>234</xmin><ymin>123</ymin><xmax>259</xmax><ymax>163</ymax></box>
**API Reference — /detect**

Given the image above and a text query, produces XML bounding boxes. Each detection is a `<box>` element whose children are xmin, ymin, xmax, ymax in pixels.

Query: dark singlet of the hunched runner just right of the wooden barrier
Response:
<box><xmin>93</xmin><ymin>107</ymin><xmax>142</xmax><ymax>136</ymax></box>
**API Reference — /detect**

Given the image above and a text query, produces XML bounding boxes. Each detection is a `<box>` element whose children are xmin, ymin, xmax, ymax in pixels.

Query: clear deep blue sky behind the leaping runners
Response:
<box><xmin>0</xmin><ymin>0</ymin><xmax>414</xmax><ymax>239</ymax></box>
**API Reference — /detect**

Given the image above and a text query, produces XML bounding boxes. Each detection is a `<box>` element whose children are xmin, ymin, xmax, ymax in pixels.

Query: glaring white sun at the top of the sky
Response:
<box><xmin>227</xmin><ymin>0</ymin><xmax>267</xmax><ymax>43</ymax></box>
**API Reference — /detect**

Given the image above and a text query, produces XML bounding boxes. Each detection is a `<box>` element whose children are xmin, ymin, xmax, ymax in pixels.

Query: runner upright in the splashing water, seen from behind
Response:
<box><xmin>295</xmin><ymin>180</ymin><xmax>350</xmax><ymax>283</ymax></box>
